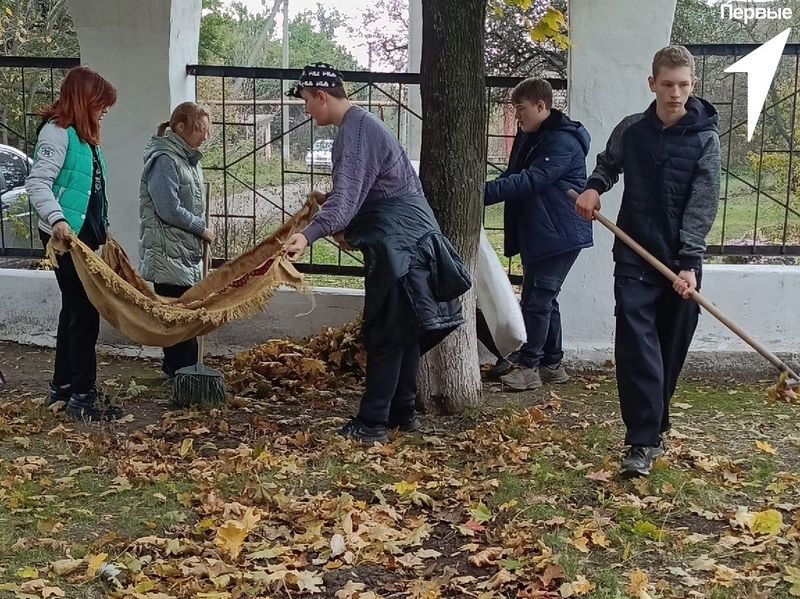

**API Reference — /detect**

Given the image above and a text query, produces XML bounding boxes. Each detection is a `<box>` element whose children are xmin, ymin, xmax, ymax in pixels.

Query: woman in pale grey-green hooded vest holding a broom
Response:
<box><xmin>139</xmin><ymin>102</ymin><xmax>214</xmax><ymax>378</ymax></box>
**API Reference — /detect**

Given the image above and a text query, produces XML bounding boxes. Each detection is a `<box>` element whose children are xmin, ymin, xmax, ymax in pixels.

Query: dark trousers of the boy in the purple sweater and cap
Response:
<box><xmin>358</xmin><ymin>341</ymin><xmax>420</xmax><ymax>425</ymax></box>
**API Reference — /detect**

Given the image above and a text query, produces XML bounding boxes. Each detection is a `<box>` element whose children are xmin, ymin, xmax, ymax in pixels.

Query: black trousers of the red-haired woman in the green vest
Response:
<box><xmin>39</xmin><ymin>231</ymin><xmax>100</xmax><ymax>393</ymax></box>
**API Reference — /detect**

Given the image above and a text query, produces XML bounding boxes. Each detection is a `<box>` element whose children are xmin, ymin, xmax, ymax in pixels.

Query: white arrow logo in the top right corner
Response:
<box><xmin>725</xmin><ymin>27</ymin><xmax>792</xmax><ymax>141</ymax></box>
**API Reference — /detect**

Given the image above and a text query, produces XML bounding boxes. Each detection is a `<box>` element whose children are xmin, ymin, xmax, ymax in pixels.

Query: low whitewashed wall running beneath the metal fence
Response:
<box><xmin>0</xmin><ymin>266</ymin><xmax>800</xmax><ymax>375</ymax></box>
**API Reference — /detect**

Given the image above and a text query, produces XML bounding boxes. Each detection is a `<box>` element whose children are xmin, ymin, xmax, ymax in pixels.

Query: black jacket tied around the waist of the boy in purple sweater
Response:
<box><xmin>344</xmin><ymin>195</ymin><xmax>472</xmax><ymax>355</ymax></box>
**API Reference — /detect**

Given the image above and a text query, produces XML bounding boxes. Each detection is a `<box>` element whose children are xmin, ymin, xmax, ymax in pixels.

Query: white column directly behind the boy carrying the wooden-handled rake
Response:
<box><xmin>559</xmin><ymin>0</ymin><xmax>676</xmax><ymax>360</ymax></box>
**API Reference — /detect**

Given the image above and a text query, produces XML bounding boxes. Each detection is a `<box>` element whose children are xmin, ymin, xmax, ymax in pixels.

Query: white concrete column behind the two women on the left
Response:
<box><xmin>69</xmin><ymin>0</ymin><xmax>201</xmax><ymax>262</ymax></box>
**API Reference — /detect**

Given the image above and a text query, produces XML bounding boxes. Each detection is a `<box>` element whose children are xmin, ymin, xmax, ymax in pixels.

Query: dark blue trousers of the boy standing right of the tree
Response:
<box><xmin>519</xmin><ymin>250</ymin><xmax>580</xmax><ymax>368</ymax></box>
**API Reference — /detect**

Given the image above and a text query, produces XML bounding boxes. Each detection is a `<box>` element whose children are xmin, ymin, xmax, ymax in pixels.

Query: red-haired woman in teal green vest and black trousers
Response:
<box><xmin>25</xmin><ymin>67</ymin><xmax>125</xmax><ymax>420</ymax></box>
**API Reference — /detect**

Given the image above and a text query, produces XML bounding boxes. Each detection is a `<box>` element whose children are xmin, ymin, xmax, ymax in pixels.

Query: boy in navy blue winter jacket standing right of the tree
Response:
<box><xmin>484</xmin><ymin>79</ymin><xmax>592</xmax><ymax>391</ymax></box>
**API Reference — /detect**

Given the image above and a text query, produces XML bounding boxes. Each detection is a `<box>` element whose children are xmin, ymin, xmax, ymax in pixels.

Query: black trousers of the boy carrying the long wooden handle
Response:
<box><xmin>614</xmin><ymin>276</ymin><xmax>700</xmax><ymax>446</ymax></box>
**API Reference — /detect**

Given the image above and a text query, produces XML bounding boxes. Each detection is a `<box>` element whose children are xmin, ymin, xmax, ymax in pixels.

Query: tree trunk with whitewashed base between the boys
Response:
<box><xmin>419</xmin><ymin>0</ymin><xmax>486</xmax><ymax>414</ymax></box>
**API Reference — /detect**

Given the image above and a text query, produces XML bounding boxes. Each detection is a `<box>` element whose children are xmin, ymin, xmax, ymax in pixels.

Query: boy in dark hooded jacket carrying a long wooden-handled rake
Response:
<box><xmin>576</xmin><ymin>46</ymin><xmax>721</xmax><ymax>476</ymax></box>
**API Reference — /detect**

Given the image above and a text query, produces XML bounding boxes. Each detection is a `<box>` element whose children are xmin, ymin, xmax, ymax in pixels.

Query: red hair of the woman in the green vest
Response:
<box><xmin>39</xmin><ymin>67</ymin><xmax>117</xmax><ymax>146</ymax></box>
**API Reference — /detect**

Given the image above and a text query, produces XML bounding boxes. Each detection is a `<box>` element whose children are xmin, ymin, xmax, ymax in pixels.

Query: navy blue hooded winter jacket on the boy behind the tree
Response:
<box><xmin>484</xmin><ymin>110</ymin><xmax>592</xmax><ymax>264</ymax></box>
